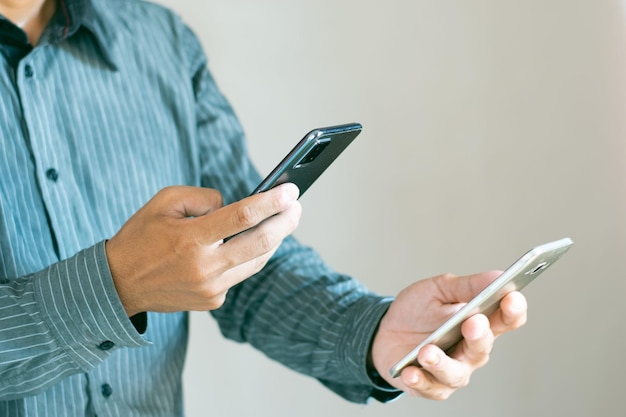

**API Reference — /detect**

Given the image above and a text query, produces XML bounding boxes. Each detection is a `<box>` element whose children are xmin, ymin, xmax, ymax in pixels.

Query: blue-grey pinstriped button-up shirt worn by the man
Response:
<box><xmin>0</xmin><ymin>0</ymin><xmax>397</xmax><ymax>417</ymax></box>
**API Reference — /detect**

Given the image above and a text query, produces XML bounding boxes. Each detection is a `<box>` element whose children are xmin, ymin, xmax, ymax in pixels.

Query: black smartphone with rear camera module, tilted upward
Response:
<box><xmin>251</xmin><ymin>123</ymin><xmax>363</xmax><ymax>197</ymax></box>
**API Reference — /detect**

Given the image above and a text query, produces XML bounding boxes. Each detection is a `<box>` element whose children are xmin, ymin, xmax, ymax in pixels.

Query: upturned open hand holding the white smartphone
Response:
<box><xmin>372</xmin><ymin>271</ymin><xmax>527</xmax><ymax>400</ymax></box>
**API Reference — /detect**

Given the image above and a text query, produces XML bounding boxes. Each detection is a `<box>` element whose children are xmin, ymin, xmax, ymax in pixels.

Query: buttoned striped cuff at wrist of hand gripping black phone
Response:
<box><xmin>34</xmin><ymin>242</ymin><xmax>150</xmax><ymax>371</ymax></box>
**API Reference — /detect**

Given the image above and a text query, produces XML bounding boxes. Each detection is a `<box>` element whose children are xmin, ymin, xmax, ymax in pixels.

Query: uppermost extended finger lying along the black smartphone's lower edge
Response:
<box><xmin>199</xmin><ymin>184</ymin><xmax>299</xmax><ymax>239</ymax></box>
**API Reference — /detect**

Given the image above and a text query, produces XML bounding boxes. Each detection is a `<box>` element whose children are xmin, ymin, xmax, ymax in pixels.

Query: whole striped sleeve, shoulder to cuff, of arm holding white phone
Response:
<box><xmin>178</xmin><ymin>24</ymin><xmax>399</xmax><ymax>403</ymax></box>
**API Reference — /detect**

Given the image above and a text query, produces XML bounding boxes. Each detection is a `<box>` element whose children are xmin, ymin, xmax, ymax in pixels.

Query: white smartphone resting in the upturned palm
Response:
<box><xmin>389</xmin><ymin>238</ymin><xmax>574</xmax><ymax>378</ymax></box>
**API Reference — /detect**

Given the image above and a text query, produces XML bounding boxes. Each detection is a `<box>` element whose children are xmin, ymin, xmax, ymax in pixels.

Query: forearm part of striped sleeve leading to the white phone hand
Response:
<box><xmin>213</xmin><ymin>238</ymin><xmax>400</xmax><ymax>403</ymax></box>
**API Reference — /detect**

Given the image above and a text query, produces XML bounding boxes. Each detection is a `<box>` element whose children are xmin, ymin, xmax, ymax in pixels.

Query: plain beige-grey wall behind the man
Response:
<box><xmin>152</xmin><ymin>0</ymin><xmax>626</xmax><ymax>417</ymax></box>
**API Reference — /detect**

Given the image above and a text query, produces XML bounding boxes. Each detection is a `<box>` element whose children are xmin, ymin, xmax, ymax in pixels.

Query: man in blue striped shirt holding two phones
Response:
<box><xmin>0</xmin><ymin>0</ymin><xmax>526</xmax><ymax>417</ymax></box>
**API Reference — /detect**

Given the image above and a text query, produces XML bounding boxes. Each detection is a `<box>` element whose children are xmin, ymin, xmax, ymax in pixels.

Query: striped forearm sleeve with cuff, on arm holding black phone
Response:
<box><xmin>0</xmin><ymin>242</ymin><xmax>149</xmax><ymax>400</ymax></box>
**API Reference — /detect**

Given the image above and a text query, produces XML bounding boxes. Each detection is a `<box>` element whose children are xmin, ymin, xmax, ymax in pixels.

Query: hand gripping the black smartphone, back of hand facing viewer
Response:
<box><xmin>106</xmin><ymin>184</ymin><xmax>301</xmax><ymax>317</ymax></box>
